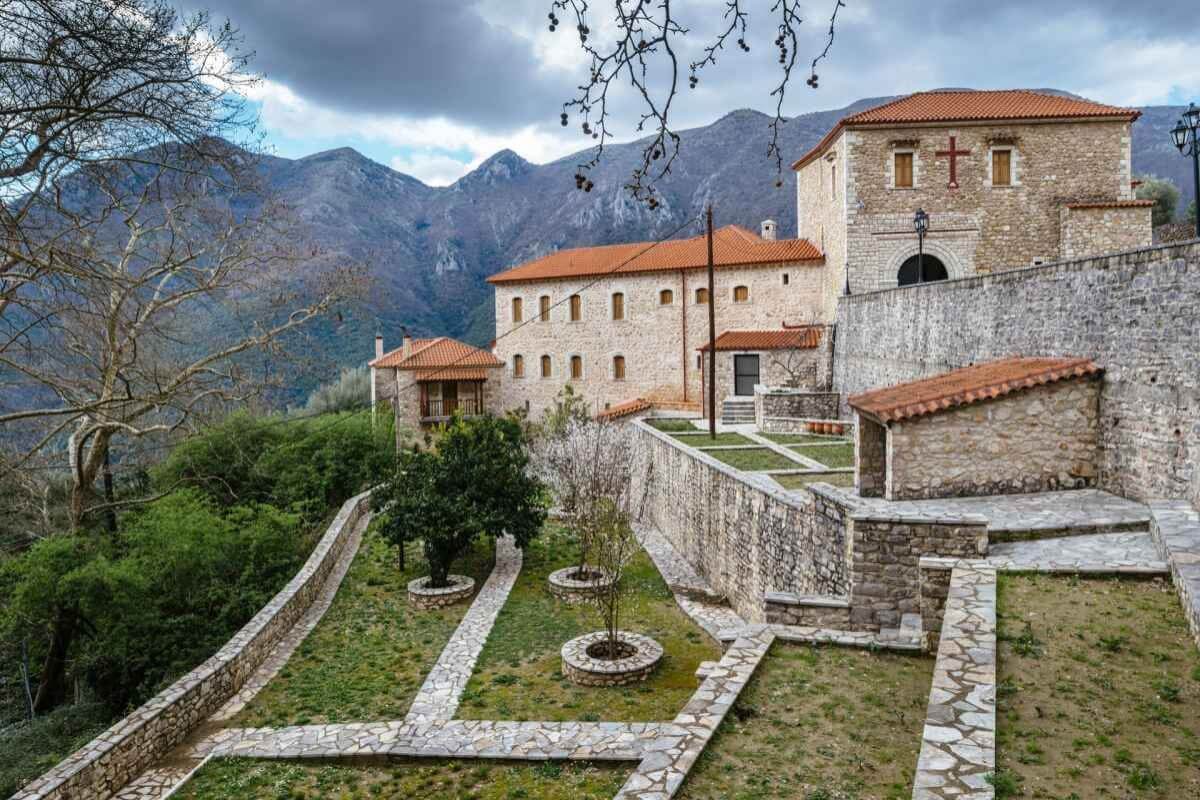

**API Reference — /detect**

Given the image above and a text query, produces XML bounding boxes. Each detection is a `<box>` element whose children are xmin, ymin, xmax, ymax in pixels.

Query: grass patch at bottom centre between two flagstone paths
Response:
<box><xmin>677</xmin><ymin>643</ymin><xmax>934</xmax><ymax>800</ymax></box>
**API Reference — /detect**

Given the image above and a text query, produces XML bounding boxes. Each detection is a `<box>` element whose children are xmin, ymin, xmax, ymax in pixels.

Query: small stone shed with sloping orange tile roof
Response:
<box><xmin>848</xmin><ymin>357</ymin><xmax>1103</xmax><ymax>500</ymax></box>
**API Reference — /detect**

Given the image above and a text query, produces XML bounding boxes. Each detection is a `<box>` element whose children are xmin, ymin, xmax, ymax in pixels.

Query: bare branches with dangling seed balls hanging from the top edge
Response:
<box><xmin>548</xmin><ymin>0</ymin><xmax>846</xmax><ymax>209</ymax></box>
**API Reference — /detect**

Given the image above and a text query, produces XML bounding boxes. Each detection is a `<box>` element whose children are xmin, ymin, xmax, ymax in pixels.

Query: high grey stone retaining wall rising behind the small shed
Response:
<box><xmin>834</xmin><ymin>241</ymin><xmax>1200</xmax><ymax>504</ymax></box>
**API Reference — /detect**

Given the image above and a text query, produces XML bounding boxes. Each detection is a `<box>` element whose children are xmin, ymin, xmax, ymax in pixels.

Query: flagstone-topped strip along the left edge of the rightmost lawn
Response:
<box><xmin>912</xmin><ymin>561</ymin><xmax>996</xmax><ymax>800</ymax></box>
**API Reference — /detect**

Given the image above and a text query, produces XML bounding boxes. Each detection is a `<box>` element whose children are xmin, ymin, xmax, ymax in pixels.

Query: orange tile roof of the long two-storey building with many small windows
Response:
<box><xmin>487</xmin><ymin>225</ymin><xmax>824</xmax><ymax>283</ymax></box>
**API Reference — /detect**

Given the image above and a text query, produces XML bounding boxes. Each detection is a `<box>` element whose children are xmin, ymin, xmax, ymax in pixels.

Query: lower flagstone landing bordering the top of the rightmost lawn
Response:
<box><xmin>988</xmin><ymin>533</ymin><xmax>1168</xmax><ymax>575</ymax></box>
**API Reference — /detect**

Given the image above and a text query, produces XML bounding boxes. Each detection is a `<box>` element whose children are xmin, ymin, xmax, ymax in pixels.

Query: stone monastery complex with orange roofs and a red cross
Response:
<box><xmin>372</xmin><ymin>90</ymin><xmax>1152</xmax><ymax>423</ymax></box>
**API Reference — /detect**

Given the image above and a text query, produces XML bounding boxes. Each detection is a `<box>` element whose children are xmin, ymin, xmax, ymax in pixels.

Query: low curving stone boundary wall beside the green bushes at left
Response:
<box><xmin>12</xmin><ymin>492</ymin><xmax>370</xmax><ymax>800</ymax></box>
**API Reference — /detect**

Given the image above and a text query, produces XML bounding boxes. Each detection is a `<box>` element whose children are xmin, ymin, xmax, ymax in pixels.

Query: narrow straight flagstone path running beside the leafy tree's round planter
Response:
<box><xmin>404</xmin><ymin>536</ymin><xmax>522</xmax><ymax>723</ymax></box>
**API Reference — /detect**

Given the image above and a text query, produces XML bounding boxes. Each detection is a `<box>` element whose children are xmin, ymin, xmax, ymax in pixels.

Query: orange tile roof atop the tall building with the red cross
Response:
<box><xmin>792</xmin><ymin>89</ymin><xmax>1141</xmax><ymax>169</ymax></box>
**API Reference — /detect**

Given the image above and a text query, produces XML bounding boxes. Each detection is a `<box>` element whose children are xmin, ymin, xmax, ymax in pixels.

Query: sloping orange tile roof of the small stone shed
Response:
<box><xmin>847</xmin><ymin>357</ymin><xmax>1103</xmax><ymax>422</ymax></box>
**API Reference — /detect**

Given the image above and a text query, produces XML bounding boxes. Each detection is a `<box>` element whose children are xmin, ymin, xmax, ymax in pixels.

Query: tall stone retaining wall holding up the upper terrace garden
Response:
<box><xmin>630</xmin><ymin>421</ymin><xmax>850</xmax><ymax>621</ymax></box>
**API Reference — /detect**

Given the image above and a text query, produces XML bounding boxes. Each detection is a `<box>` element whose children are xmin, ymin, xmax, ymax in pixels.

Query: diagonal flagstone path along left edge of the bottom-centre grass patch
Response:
<box><xmin>614</xmin><ymin>626</ymin><xmax>775</xmax><ymax>800</ymax></box>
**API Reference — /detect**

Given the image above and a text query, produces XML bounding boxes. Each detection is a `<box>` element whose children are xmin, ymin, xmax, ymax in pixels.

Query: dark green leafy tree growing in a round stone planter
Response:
<box><xmin>372</xmin><ymin>415</ymin><xmax>546</xmax><ymax>588</ymax></box>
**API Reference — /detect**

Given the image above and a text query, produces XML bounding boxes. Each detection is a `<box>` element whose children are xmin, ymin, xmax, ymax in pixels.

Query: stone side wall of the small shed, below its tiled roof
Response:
<box><xmin>884</xmin><ymin>378</ymin><xmax>1099</xmax><ymax>500</ymax></box>
